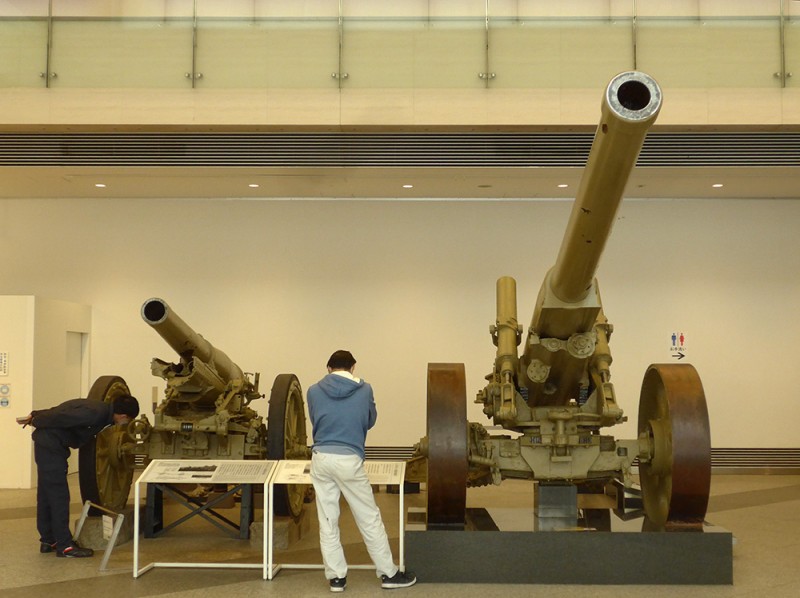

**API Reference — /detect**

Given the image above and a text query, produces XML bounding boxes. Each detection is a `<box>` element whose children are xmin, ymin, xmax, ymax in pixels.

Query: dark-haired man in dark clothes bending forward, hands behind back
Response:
<box><xmin>17</xmin><ymin>395</ymin><xmax>139</xmax><ymax>558</ymax></box>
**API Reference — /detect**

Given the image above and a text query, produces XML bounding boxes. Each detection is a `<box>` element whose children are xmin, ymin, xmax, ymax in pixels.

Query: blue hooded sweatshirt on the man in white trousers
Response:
<box><xmin>307</xmin><ymin>374</ymin><xmax>378</xmax><ymax>459</ymax></box>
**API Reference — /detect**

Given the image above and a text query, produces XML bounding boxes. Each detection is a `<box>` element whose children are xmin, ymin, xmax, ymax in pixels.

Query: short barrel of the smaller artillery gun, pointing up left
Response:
<box><xmin>142</xmin><ymin>297</ymin><xmax>244</xmax><ymax>382</ymax></box>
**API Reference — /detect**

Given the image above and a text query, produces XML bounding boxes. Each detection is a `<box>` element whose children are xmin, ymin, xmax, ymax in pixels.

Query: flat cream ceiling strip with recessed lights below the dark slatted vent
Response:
<box><xmin>0</xmin><ymin>166</ymin><xmax>800</xmax><ymax>200</ymax></box>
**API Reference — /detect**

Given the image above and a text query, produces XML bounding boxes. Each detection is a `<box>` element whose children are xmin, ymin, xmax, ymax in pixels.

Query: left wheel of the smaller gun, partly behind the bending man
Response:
<box><xmin>78</xmin><ymin>376</ymin><xmax>134</xmax><ymax>515</ymax></box>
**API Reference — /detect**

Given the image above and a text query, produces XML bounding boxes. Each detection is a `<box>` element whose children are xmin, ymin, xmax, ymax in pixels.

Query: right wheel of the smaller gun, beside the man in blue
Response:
<box><xmin>267</xmin><ymin>374</ymin><xmax>308</xmax><ymax>519</ymax></box>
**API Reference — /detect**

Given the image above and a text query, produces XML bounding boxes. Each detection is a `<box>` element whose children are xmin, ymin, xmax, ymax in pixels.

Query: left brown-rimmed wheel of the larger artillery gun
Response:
<box><xmin>427</xmin><ymin>363</ymin><xmax>469</xmax><ymax>530</ymax></box>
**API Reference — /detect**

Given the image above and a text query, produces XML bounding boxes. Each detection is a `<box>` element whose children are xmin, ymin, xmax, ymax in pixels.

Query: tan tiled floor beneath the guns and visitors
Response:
<box><xmin>0</xmin><ymin>475</ymin><xmax>800</xmax><ymax>598</ymax></box>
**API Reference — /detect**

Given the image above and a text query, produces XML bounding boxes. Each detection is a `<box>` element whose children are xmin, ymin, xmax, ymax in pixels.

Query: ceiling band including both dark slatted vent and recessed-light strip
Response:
<box><xmin>0</xmin><ymin>131</ymin><xmax>800</xmax><ymax>200</ymax></box>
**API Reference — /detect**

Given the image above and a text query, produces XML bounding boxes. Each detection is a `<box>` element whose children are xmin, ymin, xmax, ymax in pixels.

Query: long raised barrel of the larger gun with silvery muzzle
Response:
<box><xmin>549</xmin><ymin>71</ymin><xmax>661</xmax><ymax>303</ymax></box>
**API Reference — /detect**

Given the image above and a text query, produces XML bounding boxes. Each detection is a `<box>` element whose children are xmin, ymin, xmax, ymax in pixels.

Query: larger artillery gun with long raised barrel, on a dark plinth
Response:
<box><xmin>411</xmin><ymin>71</ymin><xmax>711</xmax><ymax>530</ymax></box>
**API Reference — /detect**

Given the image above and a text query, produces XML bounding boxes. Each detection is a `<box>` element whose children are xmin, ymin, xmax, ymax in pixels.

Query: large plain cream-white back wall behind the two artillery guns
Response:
<box><xmin>0</xmin><ymin>199</ymin><xmax>800</xmax><ymax>447</ymax></box>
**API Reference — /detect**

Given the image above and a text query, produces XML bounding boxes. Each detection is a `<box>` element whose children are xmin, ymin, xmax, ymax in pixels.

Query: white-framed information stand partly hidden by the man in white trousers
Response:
<box><xmin>264</xmin><ymin>460</ymin><xmax>406</xmax><ymax>580</ymax></box>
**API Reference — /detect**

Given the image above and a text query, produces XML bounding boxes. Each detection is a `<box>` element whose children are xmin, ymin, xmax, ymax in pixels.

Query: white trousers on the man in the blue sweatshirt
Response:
<box><xmin>311</xmin><ymin>451</ymin><xmax>397</xmax><ymax>579</ymax></box>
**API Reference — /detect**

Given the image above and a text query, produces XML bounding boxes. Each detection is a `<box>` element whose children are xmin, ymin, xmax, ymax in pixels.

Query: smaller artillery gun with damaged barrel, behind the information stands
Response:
<box><xmin>79</xmin><ymin>298</ymin><xmax>308</xmax><ymax>517</ymax></box>
